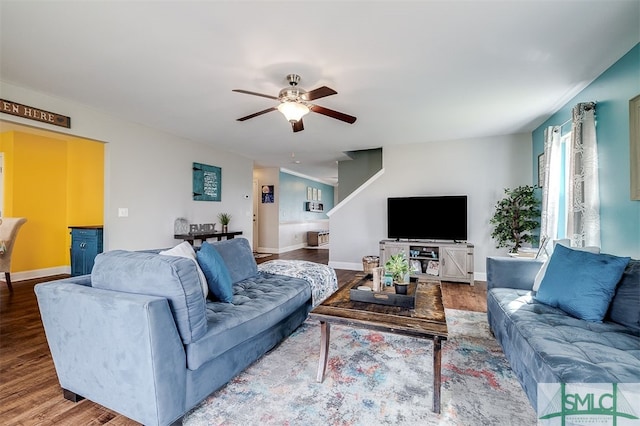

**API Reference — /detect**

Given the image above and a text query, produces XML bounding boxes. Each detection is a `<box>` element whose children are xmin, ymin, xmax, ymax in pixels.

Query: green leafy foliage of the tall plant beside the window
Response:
<box><xmin>489</xmin><ymin>185</ymin><xmax>540</xmax><ymax>253</ymax></box>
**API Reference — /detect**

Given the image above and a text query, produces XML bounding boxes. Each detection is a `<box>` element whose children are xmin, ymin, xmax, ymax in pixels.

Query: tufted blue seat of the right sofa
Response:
<box><xmin>487</xmin><ymin>288</ymin><xmax>640</xmax><ymax>407</ymax></box>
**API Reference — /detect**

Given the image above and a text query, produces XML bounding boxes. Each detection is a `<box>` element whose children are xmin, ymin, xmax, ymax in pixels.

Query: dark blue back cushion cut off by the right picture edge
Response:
<box><xmin>607</xmin><ymin>259</ymin><xmax>640</xmax><ymax>332</ymax></box>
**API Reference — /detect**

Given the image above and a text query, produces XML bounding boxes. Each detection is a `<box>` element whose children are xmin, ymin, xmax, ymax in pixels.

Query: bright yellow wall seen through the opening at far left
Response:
<box><xmin>0</xmin><ymin>132</ymin><xmax>104</xmax><ymax>272</ymax></box>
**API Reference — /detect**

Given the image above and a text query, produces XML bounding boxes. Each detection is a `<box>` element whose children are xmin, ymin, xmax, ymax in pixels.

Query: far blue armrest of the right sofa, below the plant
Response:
<box><xmin>487</xmin><ymin>257</ymin><xmax>544</xmax><ymax>290</ymax></box>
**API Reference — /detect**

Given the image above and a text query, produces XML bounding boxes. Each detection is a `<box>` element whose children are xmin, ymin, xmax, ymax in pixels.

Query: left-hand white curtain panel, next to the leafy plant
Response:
<box><xmin>540</xmin><ymin>126</ymin><xmax>562</xmax><ymax>253</ymax></box>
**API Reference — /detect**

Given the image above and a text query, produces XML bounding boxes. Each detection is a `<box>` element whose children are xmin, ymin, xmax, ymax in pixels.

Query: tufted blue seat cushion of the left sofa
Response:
<box><xmin>186</xmin><ymin>272</ymin><xmax>311</xmax><ymax>370</ymax></box>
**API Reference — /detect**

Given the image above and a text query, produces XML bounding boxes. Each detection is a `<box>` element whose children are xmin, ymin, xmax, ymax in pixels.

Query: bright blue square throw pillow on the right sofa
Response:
<box><xmin>535</xmin><ymin>245</ymin><xmax>630</xmax><ymax>322</ymax></box>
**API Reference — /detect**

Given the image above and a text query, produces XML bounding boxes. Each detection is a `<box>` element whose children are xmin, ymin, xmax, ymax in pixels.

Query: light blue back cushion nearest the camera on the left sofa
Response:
<box><xmin>91</xmin><ymin>250</ymin><xmax>207</xmax><ymax>344</ymax></box>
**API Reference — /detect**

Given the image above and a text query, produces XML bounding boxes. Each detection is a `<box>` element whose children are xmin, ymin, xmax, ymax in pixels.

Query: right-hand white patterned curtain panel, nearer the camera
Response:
<box><xmin>567</xmin><ymin>102</ymin><xmax>600</xmax><ymax>247</ymax></box>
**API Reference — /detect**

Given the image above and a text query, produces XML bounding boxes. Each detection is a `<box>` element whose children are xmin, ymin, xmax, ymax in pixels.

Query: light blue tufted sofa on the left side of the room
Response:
<box><xmin>35</xmin><ymin>238</ymin><xmax>328</xmax><ymax>425</ymax></box>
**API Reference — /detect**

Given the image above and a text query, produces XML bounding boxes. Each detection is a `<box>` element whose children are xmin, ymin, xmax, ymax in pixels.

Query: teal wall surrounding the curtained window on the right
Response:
<box><xmin>532</xmin><ymin>44</ymin><xmax>640</xmax><ymax>259</ymax></box>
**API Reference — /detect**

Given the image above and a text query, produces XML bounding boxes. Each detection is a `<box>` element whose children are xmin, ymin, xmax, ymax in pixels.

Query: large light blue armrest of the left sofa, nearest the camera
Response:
<box><xmin>35</xmin><ymin>281</ymin><xmax>186</xmax><ymax>425</ymax></box>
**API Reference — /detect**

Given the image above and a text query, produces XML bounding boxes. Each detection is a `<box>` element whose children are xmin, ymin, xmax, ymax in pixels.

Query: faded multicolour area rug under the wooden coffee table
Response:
<box><xmin>183</xmin><ymin>309</ymin><xmax>536</xmax><ymax>426</ymax></box>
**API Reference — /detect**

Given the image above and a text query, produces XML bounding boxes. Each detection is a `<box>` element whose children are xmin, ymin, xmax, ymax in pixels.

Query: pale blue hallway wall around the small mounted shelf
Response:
<box><xmin>276</xmin><ymin>171</ymin><xmax>334</xmax><ymax>223</ymax></box>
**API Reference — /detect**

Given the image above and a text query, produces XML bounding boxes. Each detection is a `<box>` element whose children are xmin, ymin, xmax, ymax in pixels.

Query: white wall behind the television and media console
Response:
<box><xmin>329</xmin><ymin>134</ymin><xmax>532</xmax><ymax>280</ymax></box>
